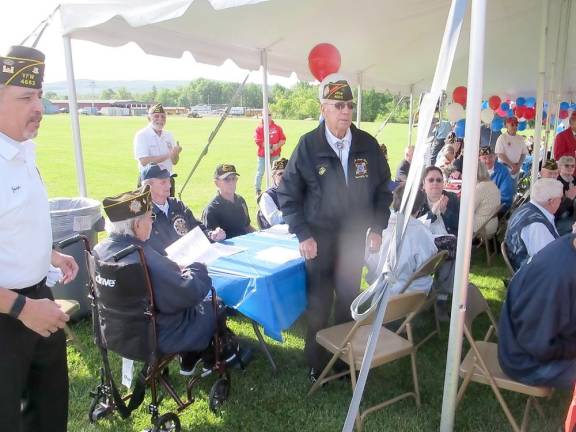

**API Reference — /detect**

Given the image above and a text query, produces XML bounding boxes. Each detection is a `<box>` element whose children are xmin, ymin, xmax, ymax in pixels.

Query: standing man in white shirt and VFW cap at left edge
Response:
<box><xmin>0</xmin><ymin>46</ymin><xmax>78</xmax><ymax>432</ymax></box>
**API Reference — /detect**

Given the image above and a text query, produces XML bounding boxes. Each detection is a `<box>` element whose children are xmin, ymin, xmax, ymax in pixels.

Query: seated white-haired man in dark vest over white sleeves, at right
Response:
<box><xmin>504</xmin><ymin>178</ymin><xmax>564</xmax><ymax>270</ymax></box>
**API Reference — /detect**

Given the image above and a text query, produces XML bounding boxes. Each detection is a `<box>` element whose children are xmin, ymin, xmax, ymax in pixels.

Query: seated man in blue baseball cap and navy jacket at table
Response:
<box><xmin>142</xmin><ymin>164</ymin><xmax>226</xmax><ymax>255</ymax></box>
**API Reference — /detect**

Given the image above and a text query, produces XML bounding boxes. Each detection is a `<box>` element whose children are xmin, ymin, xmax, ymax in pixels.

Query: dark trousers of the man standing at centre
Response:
<box><xmin>304</xmin><ymin>230</ymin><xmax>366</xmax><ymax>371</ymax></box>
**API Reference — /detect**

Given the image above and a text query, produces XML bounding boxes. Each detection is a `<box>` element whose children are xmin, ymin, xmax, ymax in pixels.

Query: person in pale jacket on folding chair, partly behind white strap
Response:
<box><xmin>365</xmin><ymin>184</ymin><xmax>438</xmax><ymax>294</ymax></box>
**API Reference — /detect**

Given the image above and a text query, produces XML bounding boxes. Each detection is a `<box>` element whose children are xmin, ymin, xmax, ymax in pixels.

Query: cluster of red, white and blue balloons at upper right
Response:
<box><xmin>446</xmin><ymin>86</ymin><xmax>576</xmax><ymax>138</ymax></box>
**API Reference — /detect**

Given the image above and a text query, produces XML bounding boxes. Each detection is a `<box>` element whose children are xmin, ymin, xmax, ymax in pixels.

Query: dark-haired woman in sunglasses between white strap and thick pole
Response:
<box><xmin>418</xmin><ymin>166</ymin><xmax>460</xmax><ymax>235</ymax></box>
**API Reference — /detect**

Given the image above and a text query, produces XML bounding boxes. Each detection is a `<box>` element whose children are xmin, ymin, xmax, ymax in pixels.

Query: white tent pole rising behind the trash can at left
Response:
<box><xmin>62</xmin><ymin>36</ymin><xmax>88</xmax><ymax>197</ymax></box>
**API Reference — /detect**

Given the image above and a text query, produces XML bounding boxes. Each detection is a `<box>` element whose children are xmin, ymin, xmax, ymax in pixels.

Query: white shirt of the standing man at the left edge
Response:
<box><xmin>0</xmin><ymin>133</ymin><xmax>52</xmax><ymax>289</ymax></box>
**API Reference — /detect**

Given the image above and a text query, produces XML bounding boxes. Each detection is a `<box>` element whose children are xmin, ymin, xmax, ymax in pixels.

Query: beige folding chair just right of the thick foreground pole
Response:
<box><xmin>456</xmin><ymin>284</ymin><xmax>552</xmax><ymax>432</ymax></box>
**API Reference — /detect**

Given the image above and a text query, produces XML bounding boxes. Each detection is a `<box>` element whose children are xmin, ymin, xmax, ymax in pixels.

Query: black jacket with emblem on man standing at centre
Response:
<box><xmin>278</xmin><ymin>122</ymin><xmax>392</xmax><ymax>241</ymax></box>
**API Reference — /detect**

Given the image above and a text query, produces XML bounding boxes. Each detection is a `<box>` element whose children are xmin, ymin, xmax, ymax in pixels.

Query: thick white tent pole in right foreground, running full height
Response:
<box><xmin>440</xmin><ymin>0</ymin><xmax>486</xmax><ymax>432</ymax></box>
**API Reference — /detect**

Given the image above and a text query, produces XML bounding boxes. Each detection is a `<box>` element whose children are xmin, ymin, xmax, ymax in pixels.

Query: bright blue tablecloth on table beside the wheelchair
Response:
<box><xmin>208</xmin><ymin>233</ymin><xmax>306</xmax><ymax>342</ymax></box>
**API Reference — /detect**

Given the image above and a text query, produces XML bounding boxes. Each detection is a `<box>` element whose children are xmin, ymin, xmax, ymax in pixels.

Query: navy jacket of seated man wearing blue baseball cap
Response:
<box><xmin>146</xmin><ymin>198</ymin><xmax>210</xmax><ymax>255</ymax></box>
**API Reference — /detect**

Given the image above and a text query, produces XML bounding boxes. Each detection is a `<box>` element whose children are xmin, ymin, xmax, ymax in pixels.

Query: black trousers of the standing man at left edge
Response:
<box><xmin>0</xmin><ymin>283</ymin><xmax>68</xmax><ymax>432</ymax></box>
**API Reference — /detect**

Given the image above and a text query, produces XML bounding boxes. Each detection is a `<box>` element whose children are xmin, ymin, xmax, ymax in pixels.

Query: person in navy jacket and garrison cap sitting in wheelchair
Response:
<box><xmin>94</xmin><ymin>188</ymin><xmax>224</xmax><ymax>375</ymax></box>
